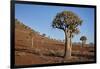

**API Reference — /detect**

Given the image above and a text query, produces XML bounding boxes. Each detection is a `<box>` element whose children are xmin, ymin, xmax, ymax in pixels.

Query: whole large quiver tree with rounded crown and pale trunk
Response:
<box><xmin>52</xmin><ymin>11</ymin><xmax>82</xmax><ymax>58</ymax></box>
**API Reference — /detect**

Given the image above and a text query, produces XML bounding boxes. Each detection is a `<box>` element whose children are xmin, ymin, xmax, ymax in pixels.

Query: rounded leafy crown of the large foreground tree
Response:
<box><xmin>52</xmin><ymin>11</ymin><xmax>82</xmax><ymax>31</ymax></box>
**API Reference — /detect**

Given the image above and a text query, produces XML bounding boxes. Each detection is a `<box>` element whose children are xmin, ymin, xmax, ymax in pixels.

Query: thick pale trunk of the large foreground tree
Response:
<box><xmin>64</xmin><ymin>30</ymin><xmax>71</xmax><ymax>58</ymax></box>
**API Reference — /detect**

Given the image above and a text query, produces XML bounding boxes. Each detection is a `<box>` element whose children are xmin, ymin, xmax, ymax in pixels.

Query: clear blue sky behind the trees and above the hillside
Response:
<box><xmin>15</xmin><ymin>4</ymin><xmax>94</xmax><ymax>43</ymax></box>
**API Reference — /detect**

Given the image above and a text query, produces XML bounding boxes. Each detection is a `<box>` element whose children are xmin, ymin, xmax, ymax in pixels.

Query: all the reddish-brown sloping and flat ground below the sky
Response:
<box><xmin>15</xmin><ymin>19</ymin><xmax>94</xmax><ymax>65</ymax></box>
